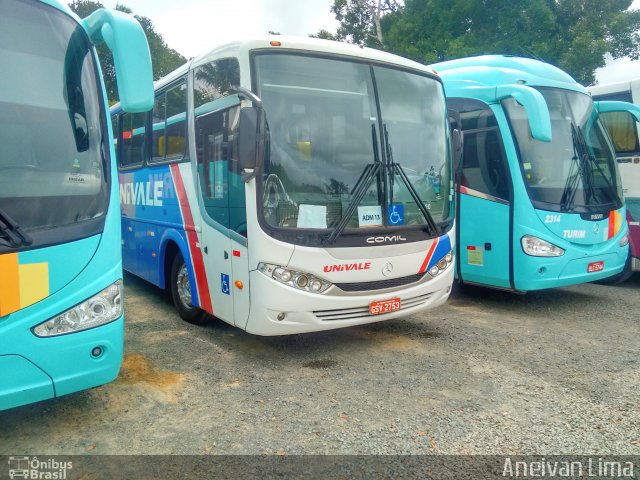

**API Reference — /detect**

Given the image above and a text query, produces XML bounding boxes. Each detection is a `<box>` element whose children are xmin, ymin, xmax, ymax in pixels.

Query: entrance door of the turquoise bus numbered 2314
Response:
<box><xmin>454</xmin><ymin>99</ymin><xmax>512</xmax><ymax>288</ymax></box>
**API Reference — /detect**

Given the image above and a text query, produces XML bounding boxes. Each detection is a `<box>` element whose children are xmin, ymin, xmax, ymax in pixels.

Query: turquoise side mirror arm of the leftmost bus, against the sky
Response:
<box><xmin>82</xmin><ymin>8</ymin><xmax>153</xmax><ymax>113</ymax></box>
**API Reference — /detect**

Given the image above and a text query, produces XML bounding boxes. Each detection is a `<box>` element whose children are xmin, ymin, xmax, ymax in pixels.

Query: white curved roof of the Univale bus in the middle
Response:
<box><xmin>111</xmin><ymin>35</ymin><xmax>436</xmax><ymax>113</ymax></box>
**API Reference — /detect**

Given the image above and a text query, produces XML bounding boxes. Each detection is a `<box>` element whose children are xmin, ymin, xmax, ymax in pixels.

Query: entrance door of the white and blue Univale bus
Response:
<box><xmin>195</xmin><ymin>102</ymin><xmax>249</xmax><ymax>328</ymax></box>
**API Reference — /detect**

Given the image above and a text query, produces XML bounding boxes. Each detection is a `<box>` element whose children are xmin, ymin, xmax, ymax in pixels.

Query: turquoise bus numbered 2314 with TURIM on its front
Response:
<box><xmin>432</xmin><ymin>55</ymin><xmax>636</xmax><ymax>292</ymax></box>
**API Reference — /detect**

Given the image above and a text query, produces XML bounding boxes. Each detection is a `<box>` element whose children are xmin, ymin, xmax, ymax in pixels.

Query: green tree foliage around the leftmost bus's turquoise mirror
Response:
<box><xmin>69</xmin><ymin>0</ymin><xmax>187</xmax><ymax>104</ymax></box>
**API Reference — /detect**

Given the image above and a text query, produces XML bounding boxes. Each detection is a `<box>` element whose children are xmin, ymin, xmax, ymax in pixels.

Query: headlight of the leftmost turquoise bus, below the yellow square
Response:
<box><xmin>32</xmin><ymin>280</ymin><xmax>122</xmax><ymax>337</ymax></box>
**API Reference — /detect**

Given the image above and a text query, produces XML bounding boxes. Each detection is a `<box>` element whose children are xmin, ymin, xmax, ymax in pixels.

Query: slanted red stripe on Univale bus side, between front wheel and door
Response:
<box><xmin>171</xmin><ymin>164</ymin><xmax>213</xmax><ymax>315</ymax></box>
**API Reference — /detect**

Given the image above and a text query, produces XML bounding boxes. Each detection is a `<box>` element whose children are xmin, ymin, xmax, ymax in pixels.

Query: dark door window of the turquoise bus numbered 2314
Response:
<box><xmin>448</xmin><ymin>99</ymin><xmax>511</xmax><ymax>200</ymax></box>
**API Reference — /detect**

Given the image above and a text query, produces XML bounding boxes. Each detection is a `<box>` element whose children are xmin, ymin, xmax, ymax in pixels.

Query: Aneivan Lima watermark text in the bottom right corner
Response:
<box><xmin>502</xmin><ymin>457</ymin><xmax>634</xmax><ymax>478</ymax></box>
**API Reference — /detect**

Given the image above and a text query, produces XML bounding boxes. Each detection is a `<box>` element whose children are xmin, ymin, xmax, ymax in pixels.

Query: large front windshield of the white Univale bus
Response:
<box><xmin>254</xmin><ymin>53</ymin><xmax>450</xmax><ymax>244</ymax></box>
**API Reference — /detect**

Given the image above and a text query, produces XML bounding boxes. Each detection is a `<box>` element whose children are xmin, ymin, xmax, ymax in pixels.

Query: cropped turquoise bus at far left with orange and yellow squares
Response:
<box><xmin>0</xmin><ymin>0</ymin><xmax>153</xmax><ymax>410</ymax></box>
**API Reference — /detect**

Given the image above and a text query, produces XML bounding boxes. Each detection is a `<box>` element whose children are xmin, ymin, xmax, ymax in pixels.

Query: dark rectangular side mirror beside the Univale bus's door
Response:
<box><xmin>235</xmin><ymin>107</ymin><xmax>266</xmax><ymax>176</ymax></box>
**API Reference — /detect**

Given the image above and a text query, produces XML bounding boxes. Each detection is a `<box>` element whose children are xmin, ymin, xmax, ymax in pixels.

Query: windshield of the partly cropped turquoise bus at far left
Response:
<box><xmin>0</xmin><ymin>0</ymin><xmax>109</xmax><ymax>253</ymax></box>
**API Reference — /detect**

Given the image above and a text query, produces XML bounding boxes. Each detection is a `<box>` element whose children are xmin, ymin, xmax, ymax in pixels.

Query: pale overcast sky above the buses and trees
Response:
<box><xmin>102</xmin><ymin>0</ymin><xmax>640</xmax><ymax>83</ymax></box>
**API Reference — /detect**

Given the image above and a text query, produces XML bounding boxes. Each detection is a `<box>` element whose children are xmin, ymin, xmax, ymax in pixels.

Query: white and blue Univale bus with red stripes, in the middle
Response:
<box><xmin>112</xmin><ymin>36</ymin><xmax>459</xmax><ymax>335</ymax></box>
